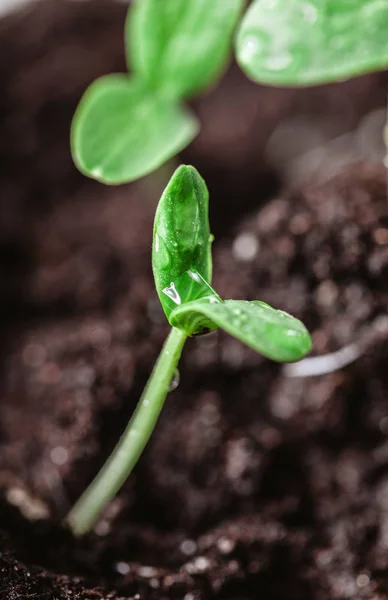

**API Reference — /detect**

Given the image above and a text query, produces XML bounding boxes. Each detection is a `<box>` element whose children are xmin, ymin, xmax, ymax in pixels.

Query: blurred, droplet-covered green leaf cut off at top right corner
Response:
<box><xmin>236</xmin><ymin>0</ymin><xmax>388</xmax><ymax>86</ymax></box>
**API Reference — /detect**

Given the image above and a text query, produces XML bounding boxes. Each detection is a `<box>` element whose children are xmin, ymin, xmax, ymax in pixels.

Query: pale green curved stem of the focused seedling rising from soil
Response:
<box><xmin>66</xmin><ymin>327</ymin><xmax>187</xmax><ymax>535</ymax></box>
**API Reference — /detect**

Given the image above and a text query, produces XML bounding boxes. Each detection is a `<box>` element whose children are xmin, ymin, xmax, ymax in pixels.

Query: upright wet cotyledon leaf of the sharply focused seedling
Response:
<box><xmin>152</xmin><ymin>165</ymin><xmax>214</xmax><ymax>318</ymax></box>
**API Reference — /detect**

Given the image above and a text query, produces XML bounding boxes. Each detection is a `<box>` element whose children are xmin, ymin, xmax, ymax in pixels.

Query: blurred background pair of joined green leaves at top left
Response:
<box><xmin>71</xmin><ymin>0</ymin><xmax>244</xmax><ymax>184</ymax></box>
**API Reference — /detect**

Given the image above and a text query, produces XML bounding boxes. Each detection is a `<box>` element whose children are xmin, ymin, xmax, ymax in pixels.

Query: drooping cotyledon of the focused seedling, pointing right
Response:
<box><xmin>170</xmin><ymin>297</ymin><xmax>311</xmax><ymax>362</ymax></box>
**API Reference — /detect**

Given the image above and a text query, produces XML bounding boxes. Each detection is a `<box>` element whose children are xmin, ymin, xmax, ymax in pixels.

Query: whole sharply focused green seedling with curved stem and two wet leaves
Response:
<box><xmin>68</xmin><ymin>166</ymin><xmax>311</xmax><ymax>535</ymax></box>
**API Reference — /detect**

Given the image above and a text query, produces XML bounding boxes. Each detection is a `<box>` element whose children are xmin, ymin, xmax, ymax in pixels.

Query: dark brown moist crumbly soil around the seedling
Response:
<box><xmin>0</xmin><ymin>0</ymin><xmax>388</xmax><ymax>600</ymax></box>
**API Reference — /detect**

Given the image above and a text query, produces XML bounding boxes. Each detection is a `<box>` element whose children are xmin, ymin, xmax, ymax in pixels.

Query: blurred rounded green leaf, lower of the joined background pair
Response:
<box><xmin>71</xmin><ymin>75</ymin><xmax>199</xmax><ymax>184</ymax></box>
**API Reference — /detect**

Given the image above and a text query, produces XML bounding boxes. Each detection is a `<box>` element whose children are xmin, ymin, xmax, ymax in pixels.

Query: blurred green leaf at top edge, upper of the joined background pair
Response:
<box><xmin>125</xmin><ymin>0</ymin><xmax>244</xmax><ymax>98</ymax></box>
